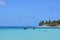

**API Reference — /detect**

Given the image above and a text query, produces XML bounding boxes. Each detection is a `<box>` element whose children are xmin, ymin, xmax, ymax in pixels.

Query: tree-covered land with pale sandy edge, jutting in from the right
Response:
<box><xmin>39</xmin><ymin>19</ymin><xmax>60</xmax><ymax>27</ymax></box>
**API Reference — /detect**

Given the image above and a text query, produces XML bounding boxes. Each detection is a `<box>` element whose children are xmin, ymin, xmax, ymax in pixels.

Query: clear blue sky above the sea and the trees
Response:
<box><xmin>0</xmin><ymin>0</ymin><xmax>60</xmax><ymax>26</ymax></box>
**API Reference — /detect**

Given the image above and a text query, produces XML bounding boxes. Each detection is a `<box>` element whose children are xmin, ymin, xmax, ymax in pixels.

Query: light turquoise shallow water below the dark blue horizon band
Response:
<box><xmin>0</xmin><ymin>28</ymin><xmax>60</xmax><ymax>40</ymax></box>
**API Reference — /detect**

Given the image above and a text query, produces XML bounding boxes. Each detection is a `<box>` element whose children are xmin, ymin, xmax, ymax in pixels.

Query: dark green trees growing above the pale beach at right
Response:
<box><xmin>39</xmin><ymin>20</ymin><xmax>60</xmax><ymax>26</ymax></box>
